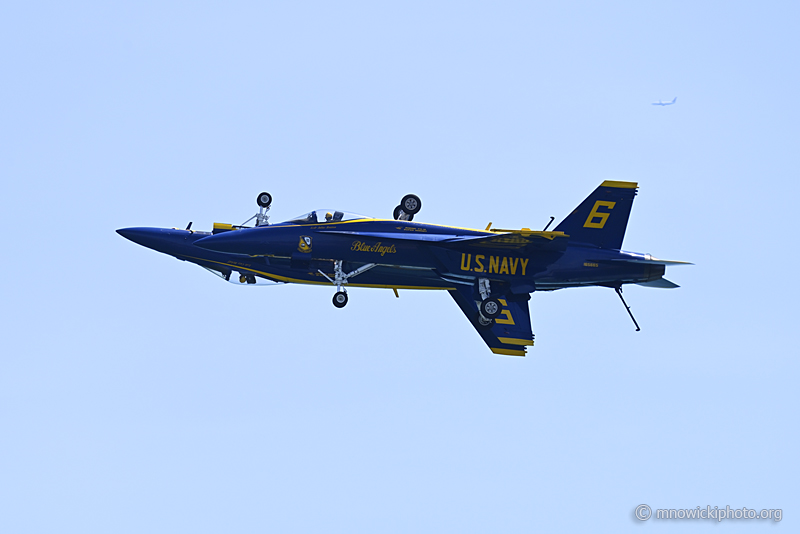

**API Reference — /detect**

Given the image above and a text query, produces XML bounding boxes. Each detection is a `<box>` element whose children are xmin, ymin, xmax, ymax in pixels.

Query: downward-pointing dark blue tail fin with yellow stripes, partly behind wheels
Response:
<box><xmin>448</xmin><ymin>286</ymin><xmax>533</xmax><ymax>356</ymax></box>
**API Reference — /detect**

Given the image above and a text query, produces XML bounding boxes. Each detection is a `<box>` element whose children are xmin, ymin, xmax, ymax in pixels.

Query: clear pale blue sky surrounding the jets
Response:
<box><xmin>0</xmin><ymin>2</ymin><xmax>800</xmax><ymax>534</ymax></box>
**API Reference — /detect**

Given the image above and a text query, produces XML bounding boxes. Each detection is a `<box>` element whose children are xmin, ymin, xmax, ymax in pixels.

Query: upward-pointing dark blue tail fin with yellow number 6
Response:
<box><xmin>556</xmin><ymin>180</ymin><xmax>638</xmax><ymax>249</ymax></box>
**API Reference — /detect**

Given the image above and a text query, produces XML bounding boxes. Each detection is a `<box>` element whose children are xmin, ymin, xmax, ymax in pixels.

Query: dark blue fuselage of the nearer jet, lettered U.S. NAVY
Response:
<box><xmin>166</xmin><ymin>219</ymin><xmax>664</xmax><ymax>293</ymax></box>
